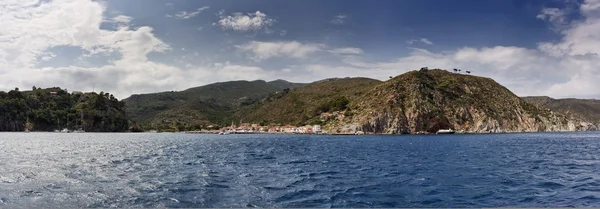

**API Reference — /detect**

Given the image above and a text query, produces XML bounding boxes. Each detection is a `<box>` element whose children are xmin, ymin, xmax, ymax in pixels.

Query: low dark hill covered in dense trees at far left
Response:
<box><xmin>0</xmin><ymin>87</ymin><xmax>129</xmax><ymax>132</ymax></box>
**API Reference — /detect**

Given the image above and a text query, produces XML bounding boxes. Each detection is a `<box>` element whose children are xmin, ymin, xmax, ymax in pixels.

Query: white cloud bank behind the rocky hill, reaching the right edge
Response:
<box><xmin>307</xmin><ymin>0</ymin><xmax>600</xmax><ymax>98</ymax></box>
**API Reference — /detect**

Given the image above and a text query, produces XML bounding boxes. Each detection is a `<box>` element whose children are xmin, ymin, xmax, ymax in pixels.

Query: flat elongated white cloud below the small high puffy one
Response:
<box><xmin>237</xmin><ymin>41</ymin><xmax>325</xmax><ymax>61</ymax></box>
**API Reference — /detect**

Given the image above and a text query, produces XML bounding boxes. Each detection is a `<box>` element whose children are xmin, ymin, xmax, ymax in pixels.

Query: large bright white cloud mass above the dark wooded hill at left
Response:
<box><xmin>0</xmin><ymin>0</ymin><xmax>247</xmax><ymax>98</ymax></box>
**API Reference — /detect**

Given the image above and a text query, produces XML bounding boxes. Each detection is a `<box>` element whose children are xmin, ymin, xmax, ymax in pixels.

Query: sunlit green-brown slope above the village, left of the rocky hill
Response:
<box><xmin>235</xmin><ymin>78</ymin><xmax>381</xmax><ymax>125</ymax></box>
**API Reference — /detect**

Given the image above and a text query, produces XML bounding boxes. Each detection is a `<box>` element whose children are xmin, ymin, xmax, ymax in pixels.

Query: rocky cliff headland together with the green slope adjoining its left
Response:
<box><xmin>235</xmin><ymin>69</ymin><xmax>597</xmax><ymax>134</ymax></box>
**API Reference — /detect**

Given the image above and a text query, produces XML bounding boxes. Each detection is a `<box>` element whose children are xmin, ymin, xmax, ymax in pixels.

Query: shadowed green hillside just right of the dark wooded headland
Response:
<box><xmin>124</xmin><ymin>80</ymin><xmax>304</xmax><ymax>130</ymax></box>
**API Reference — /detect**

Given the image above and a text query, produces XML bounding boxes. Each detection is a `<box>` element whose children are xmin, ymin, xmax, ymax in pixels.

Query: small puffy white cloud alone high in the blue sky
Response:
<box><xmin>215</xmin><ymin>11</ymin><xmax>275</xmax><ymax>32</ymax></box>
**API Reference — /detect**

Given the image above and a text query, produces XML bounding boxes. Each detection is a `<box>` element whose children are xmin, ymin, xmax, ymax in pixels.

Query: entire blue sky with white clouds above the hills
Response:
<box><xmin>0</xmin><ymin>0</ymin><xmax>600</xmax><ymax>99</ymax></box>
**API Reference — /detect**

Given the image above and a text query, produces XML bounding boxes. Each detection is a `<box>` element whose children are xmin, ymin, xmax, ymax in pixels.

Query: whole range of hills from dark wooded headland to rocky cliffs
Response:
<box><xmin>119</xmin><ymin>69</ymin><xmax>597</xmax><ymax>134</ymax></box>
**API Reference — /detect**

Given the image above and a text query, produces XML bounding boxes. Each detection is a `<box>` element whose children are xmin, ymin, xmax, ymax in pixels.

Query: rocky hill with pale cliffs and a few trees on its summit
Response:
<box><xmin>326</xmin><ymin>70</ymin><xmax>597</xmax><ymax>134</ymax></box>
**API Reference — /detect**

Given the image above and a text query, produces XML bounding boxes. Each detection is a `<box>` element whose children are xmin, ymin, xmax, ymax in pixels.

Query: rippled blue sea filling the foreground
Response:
<box><xmin>0</xmin><ymin>132</ymin><xmax>600</xmax><ymax>208</ymax></box>
